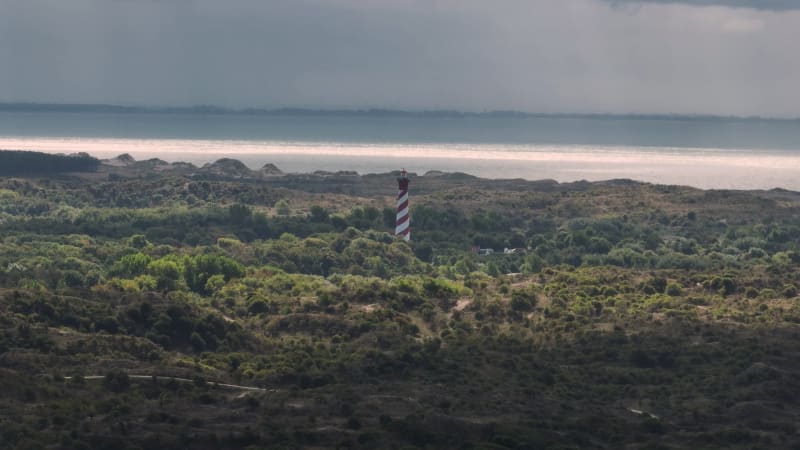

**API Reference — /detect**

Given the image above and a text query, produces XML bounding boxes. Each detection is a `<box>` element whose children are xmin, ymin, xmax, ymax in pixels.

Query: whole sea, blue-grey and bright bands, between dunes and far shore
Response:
<box><xmin>0</xmin><ymin>111</ymin><xmax>800</xmax><ymax>191</ymax></box>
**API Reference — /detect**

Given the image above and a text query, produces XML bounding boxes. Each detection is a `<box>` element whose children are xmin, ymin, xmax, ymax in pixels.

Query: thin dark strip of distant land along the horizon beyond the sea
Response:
<box><xmin>0</xmin><ymin>102</ymin><xmax>800</xmax><ymax>123</ymax></box>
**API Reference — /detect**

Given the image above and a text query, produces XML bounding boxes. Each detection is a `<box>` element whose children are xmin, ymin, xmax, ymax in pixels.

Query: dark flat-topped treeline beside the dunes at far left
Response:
<box><xmin>0</xmin><ymin>150</ymin><xmax>100</xmax><ymax>176</ymax></box>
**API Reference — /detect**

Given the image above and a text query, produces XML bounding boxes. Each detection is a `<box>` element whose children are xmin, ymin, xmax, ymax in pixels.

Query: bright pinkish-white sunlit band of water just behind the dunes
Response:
<box><xmin>0</xmin><ymin>136</ymin><xmax>800</xmax><ymax>191</ymax></box>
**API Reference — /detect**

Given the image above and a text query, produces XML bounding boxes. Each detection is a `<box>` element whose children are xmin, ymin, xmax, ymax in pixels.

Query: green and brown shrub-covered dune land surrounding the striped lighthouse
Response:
<box><xmin>0</xmin><ymin>154</ymin><xmax>800</xmax><ymax>450</ymax></box>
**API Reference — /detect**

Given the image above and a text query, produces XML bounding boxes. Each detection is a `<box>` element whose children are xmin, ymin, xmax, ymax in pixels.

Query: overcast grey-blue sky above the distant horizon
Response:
<box><xmin>0</xmin><ymin>0</ymin><xmax>800</xmax><ymax>117</ymax></box>
